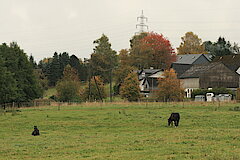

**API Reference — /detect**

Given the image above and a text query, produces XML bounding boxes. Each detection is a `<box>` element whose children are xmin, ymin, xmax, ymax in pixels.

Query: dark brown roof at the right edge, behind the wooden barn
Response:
<box><xmin>213</xmin><ymin>54</ymin><xmax>240</xmax><ymax>72</ymax></box>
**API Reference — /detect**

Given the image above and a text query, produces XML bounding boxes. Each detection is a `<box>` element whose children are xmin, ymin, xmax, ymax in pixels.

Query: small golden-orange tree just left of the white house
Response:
<box><xmin>120</xmin><ymin>72</ymin><xmax>140</xmax><ymax>102</ymax></box>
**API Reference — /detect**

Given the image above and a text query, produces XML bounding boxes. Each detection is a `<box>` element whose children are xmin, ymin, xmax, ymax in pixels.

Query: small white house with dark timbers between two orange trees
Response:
<box><xmin>137</xmin><ymin>69</ymin><xmax>164</xmax><ymax>97</ymax></box>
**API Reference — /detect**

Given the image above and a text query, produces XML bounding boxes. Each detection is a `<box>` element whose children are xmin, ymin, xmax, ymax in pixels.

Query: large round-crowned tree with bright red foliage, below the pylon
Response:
<box><xmin>130</xmin><ymin>32</ymin><xmax>176</xmax><ymax>69</ymax></box>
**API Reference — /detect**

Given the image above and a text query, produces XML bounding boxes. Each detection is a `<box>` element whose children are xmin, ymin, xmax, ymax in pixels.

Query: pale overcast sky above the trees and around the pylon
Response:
<box><xmin>0</xmin><ymin>0</ymin><xmax>240</xmax><ymax>61</ymax></box>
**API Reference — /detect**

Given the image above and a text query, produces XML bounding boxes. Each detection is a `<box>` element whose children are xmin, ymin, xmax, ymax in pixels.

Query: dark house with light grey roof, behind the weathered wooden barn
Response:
<box><xmin>171</xmin><ymin>54</ymin><xmax>211</xmax><ymax>78</ymax></box>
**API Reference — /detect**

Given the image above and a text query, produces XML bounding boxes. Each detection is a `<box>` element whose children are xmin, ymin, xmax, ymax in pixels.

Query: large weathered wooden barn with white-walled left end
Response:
<box><xmin>179</xmin><ymin>62</ymin><xmax>240</xmax><ymax>98</ymax></box>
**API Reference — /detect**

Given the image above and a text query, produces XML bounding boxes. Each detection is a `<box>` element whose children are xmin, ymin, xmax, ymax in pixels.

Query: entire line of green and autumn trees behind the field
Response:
<box><xmin>0</xmin><ymin>32</ymin><xmax>239</xmax><ymax>103</ymax></box>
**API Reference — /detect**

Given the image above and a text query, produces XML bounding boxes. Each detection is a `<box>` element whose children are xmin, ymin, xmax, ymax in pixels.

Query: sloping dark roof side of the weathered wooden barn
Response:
<box><xmin>179</xmin><ymin>62</ymin><xmax>222</xmax><ymax>79</ymax></box>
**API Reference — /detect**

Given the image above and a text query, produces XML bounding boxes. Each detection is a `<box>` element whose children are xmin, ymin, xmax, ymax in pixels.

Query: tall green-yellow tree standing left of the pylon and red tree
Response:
<box><xmin>90</xmin><ymin>34</ymin><xmax>117</xmax><ymax>82</ymax></box>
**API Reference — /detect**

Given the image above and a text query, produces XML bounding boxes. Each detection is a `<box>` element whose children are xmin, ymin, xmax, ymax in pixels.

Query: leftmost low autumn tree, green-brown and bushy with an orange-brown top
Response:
<box><xmin>56</xmin><ymin>65</ymin><xmax>81</xmax><ymax>102</ymax></box>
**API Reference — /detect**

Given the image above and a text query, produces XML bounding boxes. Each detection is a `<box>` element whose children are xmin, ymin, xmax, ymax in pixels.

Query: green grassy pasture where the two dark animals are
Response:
<box><xmin>0</xmin><ymin>103</ymin><xmax>240</xmax><ymax>160</ymax></box>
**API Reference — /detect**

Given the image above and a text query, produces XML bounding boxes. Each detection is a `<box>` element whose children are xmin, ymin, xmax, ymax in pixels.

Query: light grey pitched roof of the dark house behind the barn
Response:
<box><xmin>174</xmin><ymin>54</ymin><xmax>211</xmax><ymax>64</ymax></box>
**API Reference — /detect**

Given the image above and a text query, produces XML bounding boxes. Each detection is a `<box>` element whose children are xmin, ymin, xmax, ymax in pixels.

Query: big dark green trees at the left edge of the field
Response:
<box><xmin>0</xmin><ymin>42</ymin><xmax>43</xmax><ymax>103</ymax></box>
